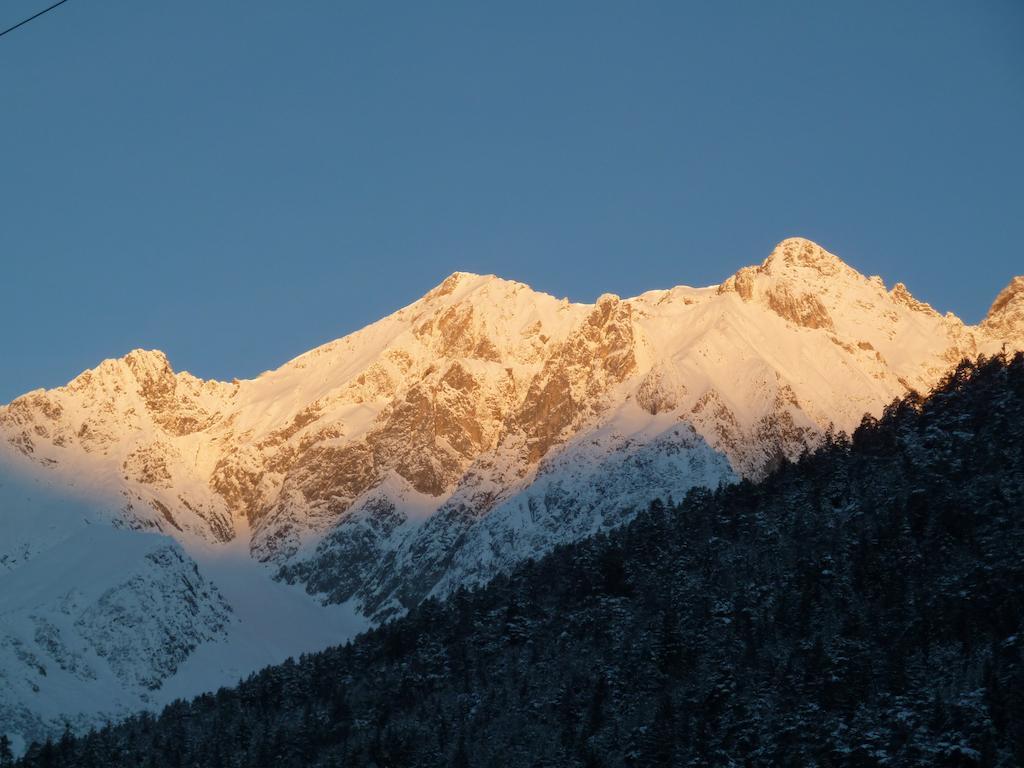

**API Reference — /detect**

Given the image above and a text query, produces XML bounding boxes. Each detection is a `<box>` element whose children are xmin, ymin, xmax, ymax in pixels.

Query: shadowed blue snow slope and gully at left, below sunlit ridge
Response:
<box><xmin>0</xmin><ymin>460</ymin><xmax>366</xmax><ymax>746</ymax></box>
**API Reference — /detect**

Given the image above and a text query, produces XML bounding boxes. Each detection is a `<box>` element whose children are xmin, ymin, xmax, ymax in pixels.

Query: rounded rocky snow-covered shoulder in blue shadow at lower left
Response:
<box><xmin>0</xmin><ymin>525</ymin><xmax>231</xmax><ymax>753</ymax></box>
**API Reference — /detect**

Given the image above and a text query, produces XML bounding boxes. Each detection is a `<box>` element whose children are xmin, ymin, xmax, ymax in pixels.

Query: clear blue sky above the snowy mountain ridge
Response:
<box><xmin>0</xmin><ymin>0</ymin><xmax>1024</xmax><ymax>401</ymax></box>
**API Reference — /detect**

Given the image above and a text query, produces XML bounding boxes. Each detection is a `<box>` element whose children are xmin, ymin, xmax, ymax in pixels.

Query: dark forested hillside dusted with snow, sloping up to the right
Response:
<box><xmin>17</xmin><ymin>354</ymin><xmax>1024</xmax><ymax>768</ymax></box>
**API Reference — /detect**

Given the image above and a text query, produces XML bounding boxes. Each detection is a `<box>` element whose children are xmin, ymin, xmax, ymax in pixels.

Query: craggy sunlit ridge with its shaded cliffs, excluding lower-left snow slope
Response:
<box><xmin>0</xmin><ymin>239</ymin><xmax>1024</xmax><ymax>615</ymax></box>
